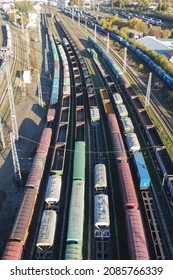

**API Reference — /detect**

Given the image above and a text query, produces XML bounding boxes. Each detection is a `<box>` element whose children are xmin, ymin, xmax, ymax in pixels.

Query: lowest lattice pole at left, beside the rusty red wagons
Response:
<box><xmin>10</xmin><ymin>132</ymin><xmax>22</xmax><ymax>185</ymax></box>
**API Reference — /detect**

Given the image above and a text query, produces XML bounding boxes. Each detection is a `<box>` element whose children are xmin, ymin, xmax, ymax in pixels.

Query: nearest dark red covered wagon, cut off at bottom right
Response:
<box><xmin>126</xmin><ymin>209</ymin><xmax>149</xmax><ymax>260</ymax></box>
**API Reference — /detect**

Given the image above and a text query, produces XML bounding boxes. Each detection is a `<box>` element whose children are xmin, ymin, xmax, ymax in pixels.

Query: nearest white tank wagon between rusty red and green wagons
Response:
<box><xmin>36</xmin><ymin>210</ymin><xmax>57</xmax><ymax>250</ymax></box>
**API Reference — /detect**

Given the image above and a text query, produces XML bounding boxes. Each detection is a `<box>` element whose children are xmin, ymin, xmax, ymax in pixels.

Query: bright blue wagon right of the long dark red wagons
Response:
<box><xmin>133</xmin><ymin>152</ymin><xmax>151</xmax><ymax>189</ymax></box>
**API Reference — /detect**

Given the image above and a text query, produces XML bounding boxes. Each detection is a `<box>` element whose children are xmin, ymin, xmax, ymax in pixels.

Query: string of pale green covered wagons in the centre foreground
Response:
<box><xmin>65</xmin><ymin>141</ymin><xmax>85</xmax><ymax>260</ymax></box>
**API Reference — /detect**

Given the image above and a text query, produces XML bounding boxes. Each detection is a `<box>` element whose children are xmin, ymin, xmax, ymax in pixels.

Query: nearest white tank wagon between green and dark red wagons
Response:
<box><xmin>94</xmin><ymin>194</ymin><xmax>110</xmax><ymax>238</ymax></box>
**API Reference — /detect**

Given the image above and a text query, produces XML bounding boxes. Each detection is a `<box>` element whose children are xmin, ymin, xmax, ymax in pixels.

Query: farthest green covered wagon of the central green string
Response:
<box><xmin>73</xmin><ymin>141</ymin><xmax>85</xmax><ymax>181</ymax></box>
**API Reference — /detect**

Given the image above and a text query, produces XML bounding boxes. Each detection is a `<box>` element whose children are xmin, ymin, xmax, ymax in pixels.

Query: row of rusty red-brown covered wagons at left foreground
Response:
<box><xmin>2</xmin><ymin>128</ymin><xmax>52</xmax><ymax>260</ymax></box>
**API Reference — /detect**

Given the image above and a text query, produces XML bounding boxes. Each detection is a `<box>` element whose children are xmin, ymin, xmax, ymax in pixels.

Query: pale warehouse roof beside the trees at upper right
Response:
<box><xmin>138</xmin><ymin>36</ymin><xmax>173</xmax><ymax>53</ymax></box>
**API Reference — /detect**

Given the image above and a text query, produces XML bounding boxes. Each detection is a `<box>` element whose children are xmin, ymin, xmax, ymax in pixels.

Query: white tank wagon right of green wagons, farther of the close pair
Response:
<box><xmin>94</xmin><ymin>163</ymin><xmax>107</xmax><ymax>191</ymax></box>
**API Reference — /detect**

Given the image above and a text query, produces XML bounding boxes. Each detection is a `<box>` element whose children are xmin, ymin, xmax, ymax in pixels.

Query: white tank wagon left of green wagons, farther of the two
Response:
<box><xmin>45</xmin><ymin>175</ymin><xmax>62</xmax><ymax>205</ymax></box>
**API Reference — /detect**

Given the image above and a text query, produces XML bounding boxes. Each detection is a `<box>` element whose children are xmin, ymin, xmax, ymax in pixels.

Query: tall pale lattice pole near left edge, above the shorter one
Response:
<box><xmin>6</xmin><ymin>54</ymin><xmax>19</xmax><ymax>140</ymax></box>
